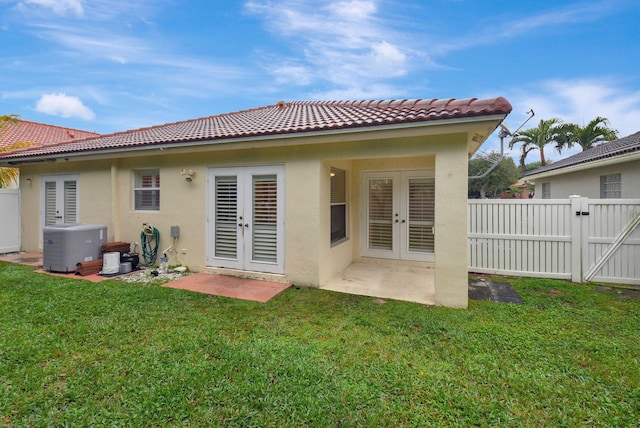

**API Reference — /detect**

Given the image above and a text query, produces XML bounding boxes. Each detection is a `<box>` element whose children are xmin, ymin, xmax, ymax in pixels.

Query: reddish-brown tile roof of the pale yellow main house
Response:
<box><xmin>0</xmin><ymin>97</ymin><xmax>511</xmax><ymax>159</ymax></box>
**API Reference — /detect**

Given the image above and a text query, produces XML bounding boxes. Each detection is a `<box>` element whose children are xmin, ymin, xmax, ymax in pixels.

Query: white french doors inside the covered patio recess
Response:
<box><xmin>361</xmin><ymin>170</ymin><xmax>435</xmax><ymax>261</ymax></box>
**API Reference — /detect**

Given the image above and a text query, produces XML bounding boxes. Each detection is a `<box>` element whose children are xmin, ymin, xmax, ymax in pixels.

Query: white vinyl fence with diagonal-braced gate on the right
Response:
<box><xmin>468</xmin><ymin>196</ymin><xmax>640</xmax><ymax>284</ymax></box>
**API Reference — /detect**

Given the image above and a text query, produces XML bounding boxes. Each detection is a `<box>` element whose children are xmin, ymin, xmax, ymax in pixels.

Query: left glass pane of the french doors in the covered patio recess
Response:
<box><xmin>369</xmin><ymin>178</ymin><xmax>393</xmax><ymax>250</ymax></box>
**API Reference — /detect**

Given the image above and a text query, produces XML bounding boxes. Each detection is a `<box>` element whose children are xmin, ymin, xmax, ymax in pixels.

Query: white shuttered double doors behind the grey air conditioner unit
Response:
<box><xmin>40</xmin><ymin>174</ymin><xmax>80</xmax><ymax>226</ymax></box>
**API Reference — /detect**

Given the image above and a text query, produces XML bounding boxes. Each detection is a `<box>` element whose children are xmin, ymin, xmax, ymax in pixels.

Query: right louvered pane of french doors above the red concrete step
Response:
<box><xmin>252</xmin><ymin>175</ymin><xmax>278</xmax><ymax>263</ymax></box>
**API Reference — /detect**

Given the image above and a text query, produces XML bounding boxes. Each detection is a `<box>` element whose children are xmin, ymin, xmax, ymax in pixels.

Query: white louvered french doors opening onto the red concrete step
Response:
<box><xmin>207</xmin><ymin>165</ymin><xmax>284</xmax><ymax>274</ymax></box>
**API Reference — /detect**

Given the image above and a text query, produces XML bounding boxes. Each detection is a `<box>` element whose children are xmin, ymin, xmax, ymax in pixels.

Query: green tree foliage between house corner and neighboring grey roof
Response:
<box><xmin>468</xmin><ymin>152</ymin><xmax>520</xmax><ymax>199</ymax></box>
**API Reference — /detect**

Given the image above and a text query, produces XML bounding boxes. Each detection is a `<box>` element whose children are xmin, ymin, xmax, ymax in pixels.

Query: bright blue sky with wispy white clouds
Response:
<box><xmin>0</xmin><ymin>0</ymin><xmax>640</xmax><ymax>162</ymax></box>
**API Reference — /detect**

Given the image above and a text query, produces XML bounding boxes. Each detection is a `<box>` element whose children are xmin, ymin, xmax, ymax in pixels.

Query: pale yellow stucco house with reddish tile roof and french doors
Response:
<box><xmin>0</xmin><ymin>97</ymin><xmax>511</xmax><ymax>307</ymax></box>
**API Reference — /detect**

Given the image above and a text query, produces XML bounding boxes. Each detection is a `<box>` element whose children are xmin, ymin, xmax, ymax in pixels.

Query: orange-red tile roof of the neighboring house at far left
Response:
<box><xmin>0</xmin><ymin>120</ymin><xmax>100</xmax><ymax>151</ymax></box>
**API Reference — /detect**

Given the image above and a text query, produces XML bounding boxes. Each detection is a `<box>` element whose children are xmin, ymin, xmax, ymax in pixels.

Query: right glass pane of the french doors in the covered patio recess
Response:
<box><xmin>407</xmin><ymin>178</ymin><xmax>435</xmax><ymax>253</ymax></box>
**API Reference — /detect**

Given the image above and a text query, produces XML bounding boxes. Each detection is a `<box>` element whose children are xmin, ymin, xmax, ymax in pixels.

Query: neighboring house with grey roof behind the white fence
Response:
<box><xmin>525</xmin><ymin>132</ymin><xmax>640</xmax><ymax>199</ymax></box>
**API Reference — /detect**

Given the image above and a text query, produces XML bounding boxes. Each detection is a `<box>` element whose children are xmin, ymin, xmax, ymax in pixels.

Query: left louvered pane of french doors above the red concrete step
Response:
<box><xmin>215</xmin><ymin>176</ymin><xmax>242</xmax><ymax>259</ymax></box>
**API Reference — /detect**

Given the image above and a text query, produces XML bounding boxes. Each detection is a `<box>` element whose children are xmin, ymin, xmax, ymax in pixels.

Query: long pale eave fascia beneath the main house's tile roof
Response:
<box><xmin>0</xmin><ymin>113</ymin><xmax>509</xmax><ymax>166</ymax></box>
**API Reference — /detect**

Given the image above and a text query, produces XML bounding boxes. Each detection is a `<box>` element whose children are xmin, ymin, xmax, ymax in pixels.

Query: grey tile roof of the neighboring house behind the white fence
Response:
<box><xmin>525</xmin><ymin>132</ymin><xmax>640</xmax><ymax>176</ymax></box>
